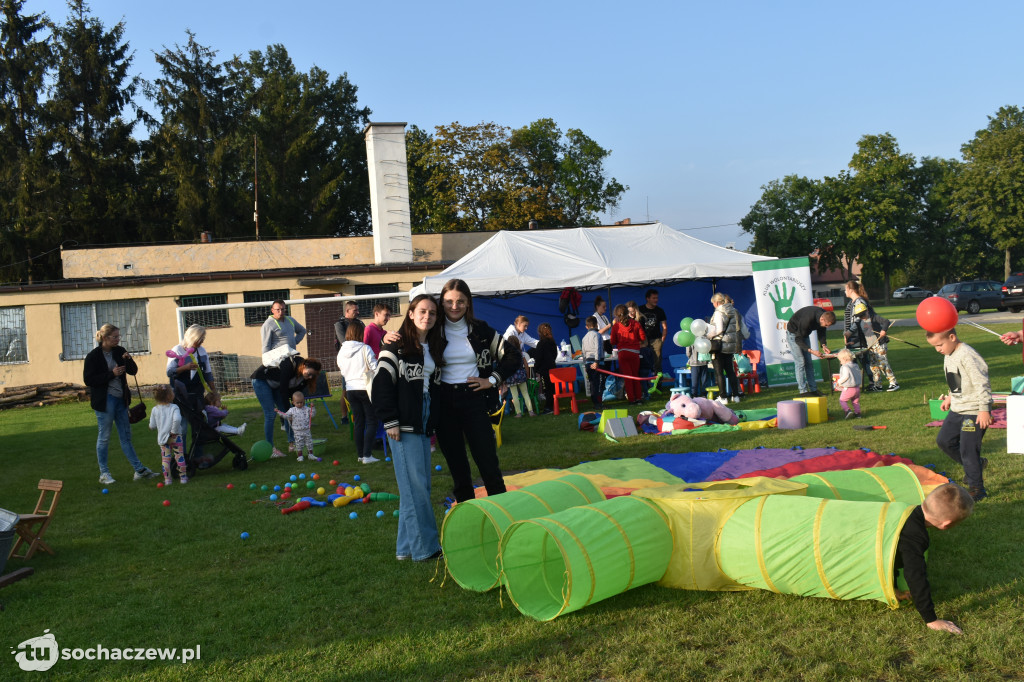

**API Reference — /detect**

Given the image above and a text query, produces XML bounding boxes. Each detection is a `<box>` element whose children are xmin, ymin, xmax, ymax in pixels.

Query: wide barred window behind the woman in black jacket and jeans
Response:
<box><xmin>60</xmin><ymin>298</ymin><xmax>150</xmax><ymax>360</ymax></box>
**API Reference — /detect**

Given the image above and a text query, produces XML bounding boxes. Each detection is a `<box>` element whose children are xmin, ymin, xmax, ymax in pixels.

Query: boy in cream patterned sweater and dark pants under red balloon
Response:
<box><xmin>926</xmin><ymin>327</ymin><xmax>992</xmax><ymax>502</ymax></box>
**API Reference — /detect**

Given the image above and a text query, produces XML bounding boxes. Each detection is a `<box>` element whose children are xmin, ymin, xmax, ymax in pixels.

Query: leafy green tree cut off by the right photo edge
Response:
<box><xmin>953</xmin><ymin>106</ymin><xmax>1024</xmax><ymax>279</ymax></box>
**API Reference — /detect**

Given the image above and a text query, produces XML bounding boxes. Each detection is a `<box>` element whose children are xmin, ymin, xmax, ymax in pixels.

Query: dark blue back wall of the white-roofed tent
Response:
<box><xmin>473</xmin><ymin>276</ymin><xmax>761</xmax><ymax>377</ymax></box>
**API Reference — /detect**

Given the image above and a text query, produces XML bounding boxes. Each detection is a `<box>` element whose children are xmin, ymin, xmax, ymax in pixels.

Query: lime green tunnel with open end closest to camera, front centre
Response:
<box><xmin>501</xmin><ymin>497</ymin><xmax>673</xmax><ymax>621</ymax></box>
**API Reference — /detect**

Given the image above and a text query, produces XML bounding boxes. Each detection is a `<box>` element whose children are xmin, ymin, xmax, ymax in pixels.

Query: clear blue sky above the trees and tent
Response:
<box><xmin>26</xmin><ymin>0</ymin><xmax>1024</xmax><ymax>248</ymax></box>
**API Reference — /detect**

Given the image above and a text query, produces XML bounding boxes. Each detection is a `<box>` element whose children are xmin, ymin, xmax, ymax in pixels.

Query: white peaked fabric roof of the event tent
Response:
<box><xmin>414</xmin><ymin>222</ymin><xmax>774</xmax><ymax>295</ymax></box>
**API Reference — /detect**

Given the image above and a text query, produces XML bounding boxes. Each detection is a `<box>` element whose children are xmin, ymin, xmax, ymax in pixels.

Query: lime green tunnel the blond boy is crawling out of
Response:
<box><xmin>715</xmin><ymin>495</ymin><xmax>913</xmax><ymax>608</ymax></box>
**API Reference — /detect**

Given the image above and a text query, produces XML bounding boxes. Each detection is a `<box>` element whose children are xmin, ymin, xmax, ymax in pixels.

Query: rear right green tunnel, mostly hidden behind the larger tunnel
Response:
<box><xmin>790</xmin><ymin>464</ymin><xmax>925</xmax><ymax>505</ymax></box>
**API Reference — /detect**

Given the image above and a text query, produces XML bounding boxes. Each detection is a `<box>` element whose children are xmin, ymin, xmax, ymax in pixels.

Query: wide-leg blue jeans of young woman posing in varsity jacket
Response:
<box><xmin>388</xmin><ymin>401</ymin><xmax>441</xmax><ymax>559</ymax></box>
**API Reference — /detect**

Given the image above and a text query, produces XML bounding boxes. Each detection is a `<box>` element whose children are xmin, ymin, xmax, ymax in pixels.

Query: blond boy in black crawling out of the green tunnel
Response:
<box><xmin>893</xmin><ymin>483</ymin><xmax>974</xmax><ymax>635</ymax></box>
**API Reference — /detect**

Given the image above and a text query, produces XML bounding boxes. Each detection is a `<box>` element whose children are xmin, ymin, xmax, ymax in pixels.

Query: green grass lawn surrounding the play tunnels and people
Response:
<box><xmin>0</xmin><ymin>326</ymin><xmax>1024</xmax><ymax>680</ymax></box>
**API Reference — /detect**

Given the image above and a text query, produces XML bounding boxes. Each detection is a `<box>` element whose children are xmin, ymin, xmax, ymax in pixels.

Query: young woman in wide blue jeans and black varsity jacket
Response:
<box><xmin>373</xmin><ymin>294</ymin><xmax>444</xmax><ymax>561</ymax></box>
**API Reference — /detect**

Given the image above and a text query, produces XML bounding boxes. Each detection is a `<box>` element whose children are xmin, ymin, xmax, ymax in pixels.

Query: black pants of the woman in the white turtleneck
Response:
<box><xmin>437</xmin><ymin>384</ymin><xmax>505</xmax><ymax>502</ymax></box>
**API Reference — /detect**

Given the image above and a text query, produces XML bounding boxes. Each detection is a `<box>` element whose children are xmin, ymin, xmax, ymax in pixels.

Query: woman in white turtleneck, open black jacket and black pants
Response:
<box><xmin>437</xmin><ymin>280</ymin><xmax>522</xmax><ymax>502</ymax></box>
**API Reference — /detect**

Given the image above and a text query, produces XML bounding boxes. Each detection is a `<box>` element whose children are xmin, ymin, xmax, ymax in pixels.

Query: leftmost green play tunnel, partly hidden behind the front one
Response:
<box><xmin>441</xmin><ymin>475</ymin><xmax>604</xmax><ymax>592</ymax></box>
